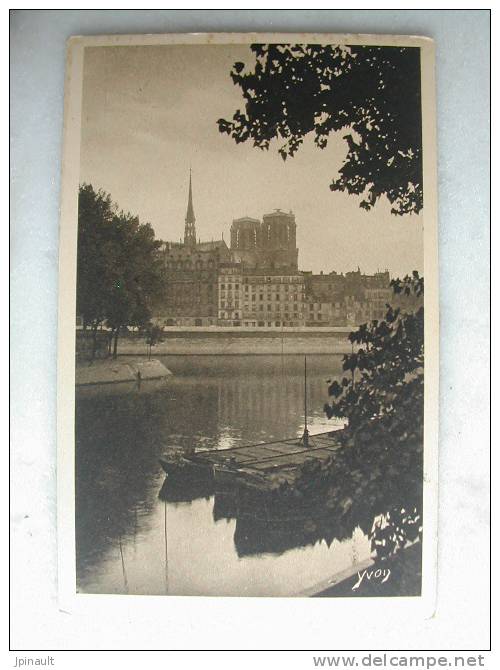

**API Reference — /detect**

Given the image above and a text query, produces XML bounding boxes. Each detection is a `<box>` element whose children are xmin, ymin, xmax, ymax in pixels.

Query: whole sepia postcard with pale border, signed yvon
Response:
<box><xmin>58</xmin><ymin>34</ymin><xmax>439</xmax><ymax>612</ymax></box>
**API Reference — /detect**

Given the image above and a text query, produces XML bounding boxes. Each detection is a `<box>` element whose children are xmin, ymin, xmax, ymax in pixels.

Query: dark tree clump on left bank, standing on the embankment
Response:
<box><xmin>77</xmin><ymin>184</ymin><xmax>164</xmax><ymax>357</ymax></box>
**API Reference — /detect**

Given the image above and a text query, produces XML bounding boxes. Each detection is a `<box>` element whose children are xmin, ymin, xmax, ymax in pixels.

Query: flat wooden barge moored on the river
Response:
<box><xmin>160</xmin><ymin>430</ymin><xmax>342</xmax><ymax>491</ymax></box>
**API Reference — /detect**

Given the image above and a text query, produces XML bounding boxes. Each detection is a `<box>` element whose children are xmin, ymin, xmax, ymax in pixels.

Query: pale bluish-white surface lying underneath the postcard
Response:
<box><xmin>11</xmin><ymin>10</ymin><xmax>489</xmax><ymax>649</ymax></box>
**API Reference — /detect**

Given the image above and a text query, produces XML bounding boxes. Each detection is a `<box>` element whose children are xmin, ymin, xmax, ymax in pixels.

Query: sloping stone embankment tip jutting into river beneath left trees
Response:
<box><xmin>75</xmin><ymin>357</ymin><xmax>172</xmax><ymax>386</ymax></box>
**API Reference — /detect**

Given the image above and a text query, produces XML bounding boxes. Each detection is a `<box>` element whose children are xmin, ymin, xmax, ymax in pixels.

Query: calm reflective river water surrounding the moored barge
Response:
<box><xmin>76</xmin><ymin>355</ymin><xmax>370</xmax><ymax>596</ymax></box>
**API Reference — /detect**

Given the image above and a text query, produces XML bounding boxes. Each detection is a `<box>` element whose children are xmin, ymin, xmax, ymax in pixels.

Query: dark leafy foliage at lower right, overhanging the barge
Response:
<box><xmin>266</xmin><ymin>272</ymin><xmax>424</xmax><ymax>558</ymax></box>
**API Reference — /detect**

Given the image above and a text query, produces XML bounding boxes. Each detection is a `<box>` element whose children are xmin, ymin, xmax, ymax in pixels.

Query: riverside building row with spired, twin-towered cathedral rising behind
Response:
<box><xmin>155</xmin><ymin>174</ymin><xmax>418</xmax><ymax>329</ymax></box>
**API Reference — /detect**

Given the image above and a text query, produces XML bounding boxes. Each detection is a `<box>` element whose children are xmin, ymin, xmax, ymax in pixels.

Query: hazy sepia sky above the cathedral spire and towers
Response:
<box><xmin>80</xmin><ymin>45</ymin><xmax>423</xmax><ymax>275</ymax></box>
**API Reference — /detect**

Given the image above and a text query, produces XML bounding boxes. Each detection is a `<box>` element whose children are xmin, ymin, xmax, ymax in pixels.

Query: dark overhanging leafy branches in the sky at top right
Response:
<box><xmin>218</xmin><ymin>44</ymin><xmax>423</xmax><ymax>214</ymax></box>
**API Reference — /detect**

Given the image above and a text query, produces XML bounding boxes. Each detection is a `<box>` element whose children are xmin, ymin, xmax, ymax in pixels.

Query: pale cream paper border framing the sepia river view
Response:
<box><xmin>57</xmin><ymin>33</ymin><xmax>439</xmax><ymax>632</ymax></box>
